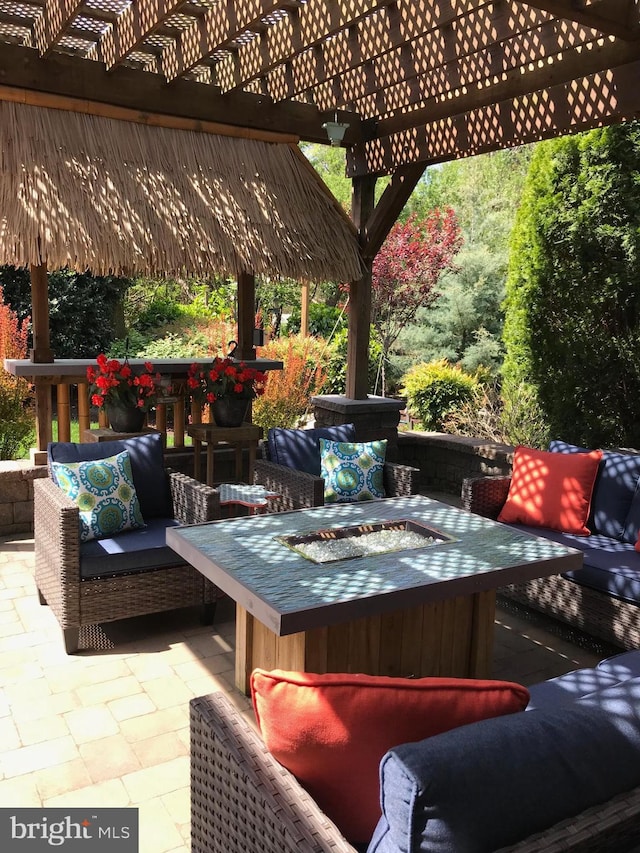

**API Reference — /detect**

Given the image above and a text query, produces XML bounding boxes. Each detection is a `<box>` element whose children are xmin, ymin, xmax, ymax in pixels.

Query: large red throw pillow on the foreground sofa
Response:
<box><xmin>251</xmin><ymin>669</ymin><xmax>529</xmax><ymax>844</ymax></box>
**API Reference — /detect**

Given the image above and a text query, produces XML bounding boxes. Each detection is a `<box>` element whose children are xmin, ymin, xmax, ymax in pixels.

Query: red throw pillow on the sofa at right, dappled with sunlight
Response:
<box><xmin>498</xmin><ymin>446</ymin><xmax>602</xmax><ymax>536</ymax></box>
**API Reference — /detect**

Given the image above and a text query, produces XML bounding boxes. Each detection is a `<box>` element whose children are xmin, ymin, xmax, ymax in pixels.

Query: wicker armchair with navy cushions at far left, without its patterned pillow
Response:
<box><xmin>34</xmin><ymin>433</ymin><xmax>220</xmax><ymax>654</ymax></box>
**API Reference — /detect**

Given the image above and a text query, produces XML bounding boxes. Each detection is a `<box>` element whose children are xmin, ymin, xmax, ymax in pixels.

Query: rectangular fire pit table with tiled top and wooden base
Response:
<box><xmin>167</xmin><ymin>495</ymin><xmax>582</xmax><ymax>693</ymax></box>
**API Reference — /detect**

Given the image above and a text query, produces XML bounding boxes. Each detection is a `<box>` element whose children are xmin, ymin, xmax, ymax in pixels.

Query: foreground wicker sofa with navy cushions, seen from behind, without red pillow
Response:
<box><xmin>190</xmin><ymin>653</ymin><xmax>640</xmax><ymax>853</ymax></box>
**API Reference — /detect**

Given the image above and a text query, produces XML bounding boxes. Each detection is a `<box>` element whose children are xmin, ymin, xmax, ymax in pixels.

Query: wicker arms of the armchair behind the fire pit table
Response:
<box><xmin>253</xmin><ymin>441</ymin><xmax>420</xmax><ymax>512</ymax></box>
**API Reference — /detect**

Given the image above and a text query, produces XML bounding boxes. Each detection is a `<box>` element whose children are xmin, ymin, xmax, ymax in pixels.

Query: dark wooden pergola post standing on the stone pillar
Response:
<box><xmin>346</xmin><ymin>175</ymin><xmax>376</xmax><ymax>400</ymax></box>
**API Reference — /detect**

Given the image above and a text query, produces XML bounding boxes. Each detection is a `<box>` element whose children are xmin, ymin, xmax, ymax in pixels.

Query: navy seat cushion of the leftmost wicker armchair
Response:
<box><xmin>80</xmin><ymin>518</ymin><xmax>186</xmax><ymax>580</ymax></box>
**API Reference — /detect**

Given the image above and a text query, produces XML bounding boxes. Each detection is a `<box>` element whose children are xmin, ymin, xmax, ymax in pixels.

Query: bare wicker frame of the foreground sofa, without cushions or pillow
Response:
<box><xmin>191</xmin><ymin>693</ymin><xmax>640</xmax><ymax>853</ymax></box>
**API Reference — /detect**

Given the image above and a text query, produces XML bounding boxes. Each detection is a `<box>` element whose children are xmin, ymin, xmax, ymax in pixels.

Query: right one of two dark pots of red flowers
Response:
<box><xmin>187</xmin><ymin>358</ymin><xmax>267</xmax><ymax>426</ymax></box>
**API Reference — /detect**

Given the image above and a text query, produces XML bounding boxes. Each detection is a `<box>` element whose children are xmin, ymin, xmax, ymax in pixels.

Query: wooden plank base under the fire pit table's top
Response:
<box><xmin>236</xmin><ymin>591</ymin><xmax>496</xmax><ymax>695</ymax></box>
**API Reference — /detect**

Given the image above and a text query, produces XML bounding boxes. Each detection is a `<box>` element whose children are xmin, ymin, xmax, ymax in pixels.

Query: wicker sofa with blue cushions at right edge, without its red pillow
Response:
<box><xmin>462</xmin><ymin>441</ymin><xmax>640</xmax><ymax>649</ymax></box>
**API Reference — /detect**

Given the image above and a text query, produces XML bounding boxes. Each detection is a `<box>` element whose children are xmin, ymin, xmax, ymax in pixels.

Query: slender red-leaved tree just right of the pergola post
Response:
<box><xmin>371</xmin><ymin>208</ymin><xmax>462</xmax><ymax>395</ymax></box>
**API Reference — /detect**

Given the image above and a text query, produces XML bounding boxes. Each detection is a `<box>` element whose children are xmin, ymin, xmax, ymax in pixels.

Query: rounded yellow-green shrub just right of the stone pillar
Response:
<box><xmin>400</xmin><ymin>359</ymin><xmax>478</xmax><ymax>431</ymax></box>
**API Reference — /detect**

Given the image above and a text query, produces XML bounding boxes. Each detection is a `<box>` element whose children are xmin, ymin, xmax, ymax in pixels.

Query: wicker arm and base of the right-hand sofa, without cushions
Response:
<box><xmin>462</xmin><ymin>476</ymin><xmax>640</xmax><ymax>649</ymax></box>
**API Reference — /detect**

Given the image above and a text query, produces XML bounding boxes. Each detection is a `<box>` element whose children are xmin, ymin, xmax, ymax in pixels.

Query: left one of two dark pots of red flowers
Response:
<box><xmin>87</xmin><ymin>353</ymin><xmax>162</xmax><ymax>432</ymax></box>
